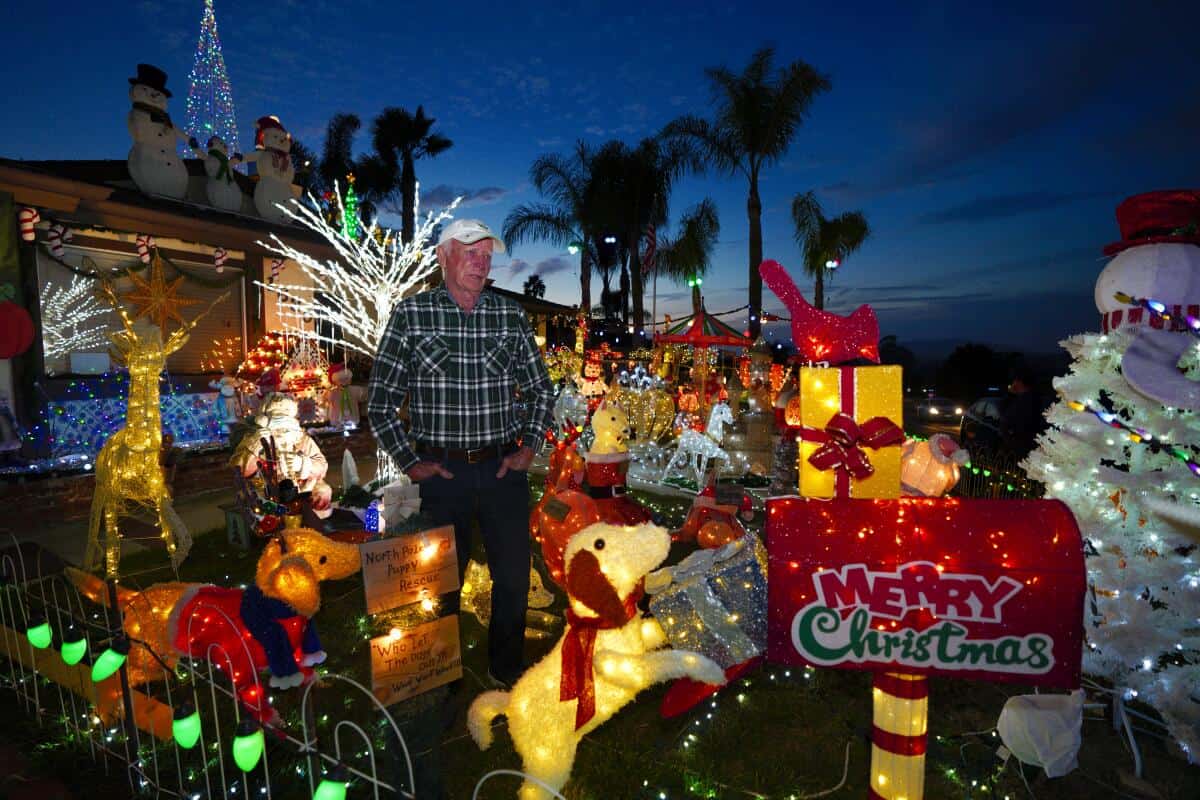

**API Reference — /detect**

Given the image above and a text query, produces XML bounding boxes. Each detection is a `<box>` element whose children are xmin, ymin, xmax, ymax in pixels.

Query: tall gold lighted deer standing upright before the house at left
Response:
<box><xmin>84</xmin><ymin>284</ymin><xmax>228</xmax><ymax>578</ymax></box>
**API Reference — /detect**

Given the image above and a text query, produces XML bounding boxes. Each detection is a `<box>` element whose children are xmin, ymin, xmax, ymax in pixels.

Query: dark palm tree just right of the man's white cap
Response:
<box><xmin>502</xmin><ymin>142</ymin><xmax>597</xmax><ymax>309</ymax></box>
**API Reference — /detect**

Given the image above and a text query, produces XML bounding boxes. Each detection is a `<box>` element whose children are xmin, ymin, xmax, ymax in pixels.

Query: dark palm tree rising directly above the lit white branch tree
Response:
<box><xmin>360</xmin><ymin>106</ymin><xmax>454</xmax><ymax>243</ymax></box>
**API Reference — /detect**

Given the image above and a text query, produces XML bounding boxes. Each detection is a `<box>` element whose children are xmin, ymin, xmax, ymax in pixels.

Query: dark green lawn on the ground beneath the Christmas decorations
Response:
<box><xmin>16</xmin><ymin>484</ymin><xmax>1200</xmax><ymax>800</ymax></box>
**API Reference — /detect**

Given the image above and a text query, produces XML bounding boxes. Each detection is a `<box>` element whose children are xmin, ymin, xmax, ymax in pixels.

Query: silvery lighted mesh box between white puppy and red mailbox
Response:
<box><xmin>646</xmin><ymin>534</ymin><xmax>767</xmax><ymax>669</ymax></box>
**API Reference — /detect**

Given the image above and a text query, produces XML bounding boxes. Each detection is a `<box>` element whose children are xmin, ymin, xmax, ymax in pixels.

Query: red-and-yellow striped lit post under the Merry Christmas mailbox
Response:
<box><xmin>868</xmin><ymin>672</ymin><xmax>929</xmax><ymax>800</ymax></box>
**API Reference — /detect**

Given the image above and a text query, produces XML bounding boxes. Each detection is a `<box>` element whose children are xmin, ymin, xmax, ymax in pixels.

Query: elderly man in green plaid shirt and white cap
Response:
<box><xmin>367</xmin><ymin>219</ymin><xmax>554</xmax><ymax>685</ymax></box>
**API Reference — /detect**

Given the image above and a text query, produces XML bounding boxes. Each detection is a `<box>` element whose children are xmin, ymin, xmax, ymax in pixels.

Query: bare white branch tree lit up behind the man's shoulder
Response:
<box><xmin>258</xmin><ymin>187</ymin><xmax>462</xmax><ymax>477</ymax></box>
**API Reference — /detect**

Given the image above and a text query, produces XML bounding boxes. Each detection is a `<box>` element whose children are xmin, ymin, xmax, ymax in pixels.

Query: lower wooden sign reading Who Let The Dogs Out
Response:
<box><xmin>371</xmin><ymin>615</ymin><xmax>462</xmax><ymax>705</ymax></box>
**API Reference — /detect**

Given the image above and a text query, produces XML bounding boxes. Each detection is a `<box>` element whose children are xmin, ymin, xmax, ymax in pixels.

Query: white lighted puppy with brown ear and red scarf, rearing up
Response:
<box><xmin>467</xmin><ymin>523</ymin><xmax>725</xmax><ymax>800</ymax></box>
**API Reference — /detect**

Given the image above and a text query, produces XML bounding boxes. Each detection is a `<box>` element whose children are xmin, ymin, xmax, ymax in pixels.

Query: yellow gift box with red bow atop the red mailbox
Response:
<box><xmin>797</xmin><ymin>367</ymin><xmax>904</xmax><ymax>499</ymax></box>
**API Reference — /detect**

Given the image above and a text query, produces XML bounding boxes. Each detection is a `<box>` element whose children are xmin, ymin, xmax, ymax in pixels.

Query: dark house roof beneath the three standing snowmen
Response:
<box><xmin>0</xmin><ymin>158</ymin><xmax>334</xmax><ymax>254</ymax></box>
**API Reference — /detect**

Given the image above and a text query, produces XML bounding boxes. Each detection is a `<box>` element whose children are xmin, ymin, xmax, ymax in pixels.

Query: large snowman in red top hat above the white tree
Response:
<box><xmin>1096</xmin><ymin>190</ymin><xmax>1200</xmax><ymax>410</ymax></box>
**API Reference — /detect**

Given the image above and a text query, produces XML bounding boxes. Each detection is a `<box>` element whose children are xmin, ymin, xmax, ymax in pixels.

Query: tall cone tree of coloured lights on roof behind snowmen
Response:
<box><xmin>179</xmin><ymin>0</ymin><xmax>238</xmax><ymax>158</ymax></box>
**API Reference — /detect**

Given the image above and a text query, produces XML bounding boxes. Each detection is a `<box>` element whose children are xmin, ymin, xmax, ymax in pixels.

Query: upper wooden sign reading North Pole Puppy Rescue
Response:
<box><xmin>361</xmin><ymin>525</ymin><xmax>458</xmax><ymax>614</ymax></box>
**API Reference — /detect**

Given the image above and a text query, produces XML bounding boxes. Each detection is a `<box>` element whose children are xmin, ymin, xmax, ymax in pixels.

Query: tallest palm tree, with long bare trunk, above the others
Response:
<box><xmin>662</xmin><ymin>47</ymin><xmax>830</xmax><ymax>338</ymax></box>
